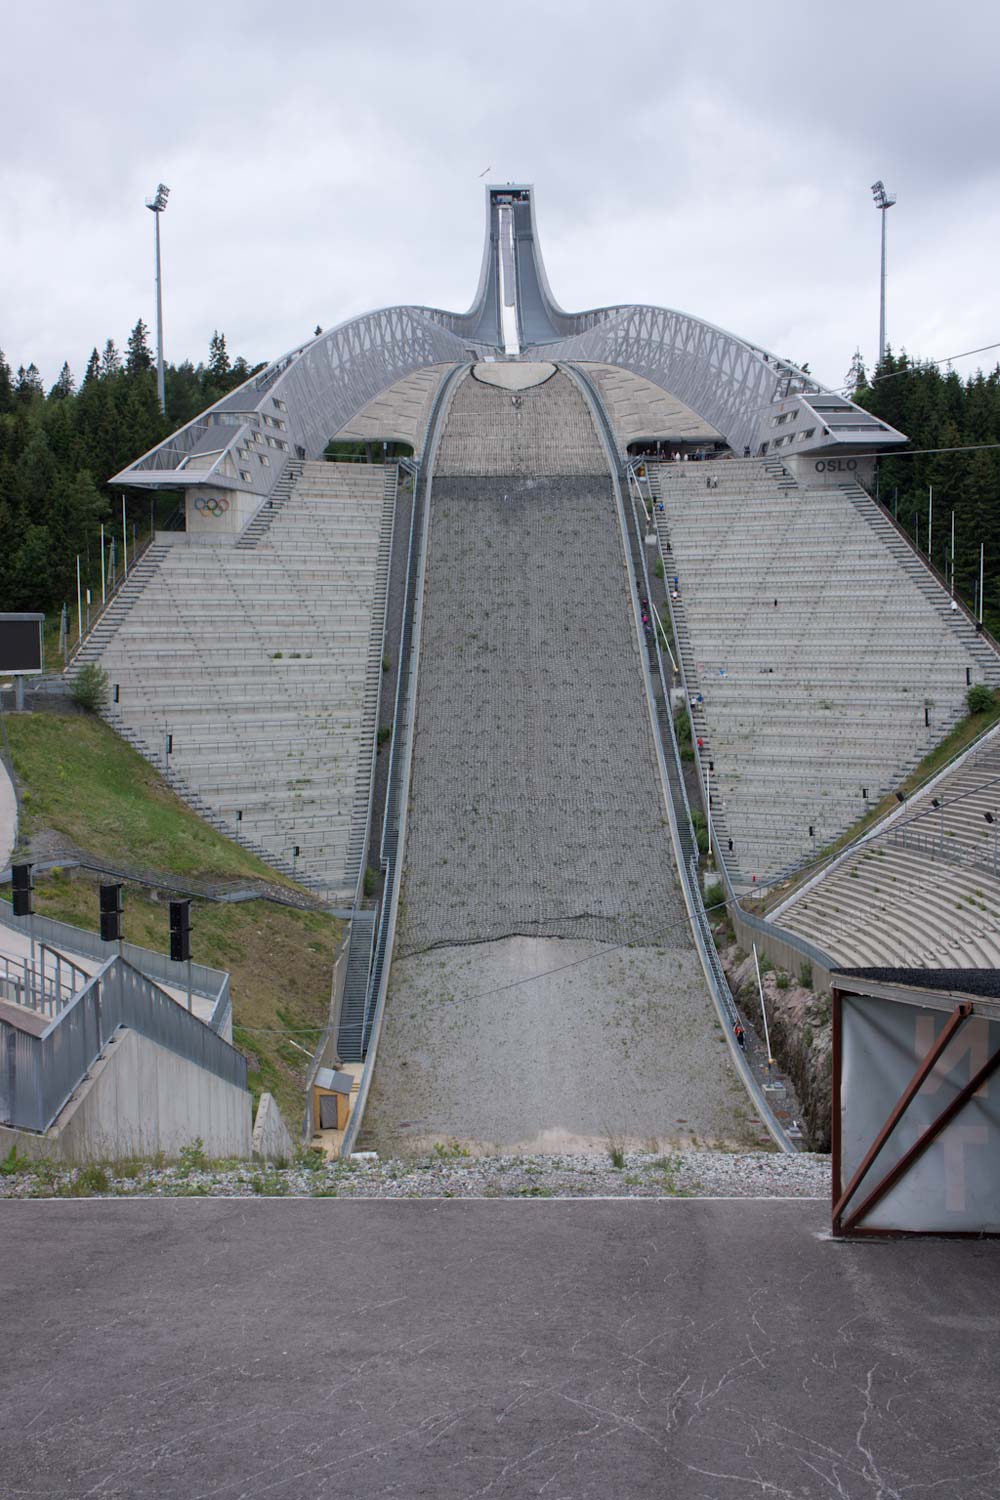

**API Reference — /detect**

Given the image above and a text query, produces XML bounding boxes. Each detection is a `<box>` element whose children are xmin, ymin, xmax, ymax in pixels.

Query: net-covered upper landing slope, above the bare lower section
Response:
<box><xmin>396</xmin><ymin>374</ymin><xmax>687</xmax><ymax>954</ymax></box>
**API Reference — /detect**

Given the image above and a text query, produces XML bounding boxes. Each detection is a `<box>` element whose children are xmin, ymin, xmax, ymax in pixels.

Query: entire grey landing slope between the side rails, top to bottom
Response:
<box><xmin>363</xmin><ymin>372</ymin><xmax>762</xmax><ymax>1151</ymax></box>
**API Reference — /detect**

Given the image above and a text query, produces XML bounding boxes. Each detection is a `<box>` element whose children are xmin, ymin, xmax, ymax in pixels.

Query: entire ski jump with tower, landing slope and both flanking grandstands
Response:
<box><xmin>89</xmin><ymin>185</ymin><xmax>1000</xmax><ymax>1149</ymax></box>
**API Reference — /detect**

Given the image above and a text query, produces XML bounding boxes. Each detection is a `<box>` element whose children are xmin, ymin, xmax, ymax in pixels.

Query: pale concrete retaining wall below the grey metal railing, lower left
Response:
<box><xmin>0</xmin><ymin>1026</ymin><xmax>250</xmax><ymax>1163</ymax></box>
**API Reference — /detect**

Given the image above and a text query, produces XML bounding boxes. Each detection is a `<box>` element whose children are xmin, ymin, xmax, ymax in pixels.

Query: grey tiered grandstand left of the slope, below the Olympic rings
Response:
<box><xmin>78</xmin><ymin>462</ymin><xmax>394</xmax><ymax>897</ymax></box>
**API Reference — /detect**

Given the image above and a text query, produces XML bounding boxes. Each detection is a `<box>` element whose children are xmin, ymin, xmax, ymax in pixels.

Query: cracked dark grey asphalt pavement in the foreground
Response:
<box><xmin>0</xmin><ymin>1199</ymin><xmax>1000</xmax><ymax>1500</ymax></box>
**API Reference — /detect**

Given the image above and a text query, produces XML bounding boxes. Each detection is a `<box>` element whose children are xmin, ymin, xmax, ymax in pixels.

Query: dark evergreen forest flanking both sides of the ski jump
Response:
<box><xmin>0</xmin><ymin>331</ymin><xmax>1000</xmax><ymax>636</ymax></box>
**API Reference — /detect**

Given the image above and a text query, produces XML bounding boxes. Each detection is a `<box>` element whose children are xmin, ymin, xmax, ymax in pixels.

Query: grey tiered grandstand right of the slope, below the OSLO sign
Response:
<box><xmin>651</xmin><ymin>459</ymin><xmax>1000</xmax><ymax>885</ymax></box>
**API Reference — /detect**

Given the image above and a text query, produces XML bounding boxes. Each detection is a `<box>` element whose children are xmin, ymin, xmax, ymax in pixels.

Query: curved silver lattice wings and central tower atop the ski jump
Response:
<box><xmin>114</xmin><ymin>183</ymin><xmax>907</xmax><ymax>497</ymax></box>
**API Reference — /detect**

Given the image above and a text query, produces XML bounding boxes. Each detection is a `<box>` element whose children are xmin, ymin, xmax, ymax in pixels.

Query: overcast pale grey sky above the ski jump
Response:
<box><xmin>0</xmin><ymin>0</ymin><xmax>1000</xmax><ymax>386</ymax></box>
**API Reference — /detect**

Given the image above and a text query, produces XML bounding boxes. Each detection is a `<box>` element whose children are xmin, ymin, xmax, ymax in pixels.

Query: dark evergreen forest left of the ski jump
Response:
<box><xmin>0</xmin><ymin>328</ymin><xmax>259</xmax><ymax>629</ymax></box>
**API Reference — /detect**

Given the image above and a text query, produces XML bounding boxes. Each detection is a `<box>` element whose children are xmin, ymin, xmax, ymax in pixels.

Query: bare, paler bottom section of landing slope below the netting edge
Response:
<box><xmin>363</xmin><ymin>938</ymin><xmax>768</xmax><ymax>1154</ymax></box>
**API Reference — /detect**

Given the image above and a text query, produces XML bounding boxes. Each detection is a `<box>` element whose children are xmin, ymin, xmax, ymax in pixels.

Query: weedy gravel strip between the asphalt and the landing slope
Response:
<box><xmin>0</xmin><ymin>1146</ymin><xmax>829</xmax><ymax>1199</ymax></box>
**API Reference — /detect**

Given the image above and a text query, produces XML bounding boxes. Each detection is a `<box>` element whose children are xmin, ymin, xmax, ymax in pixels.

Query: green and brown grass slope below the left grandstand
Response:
<box><xmin>7</xmin><ymin>714</ymin><xmax>343</xmax><ymax>1136</ymax></box>
